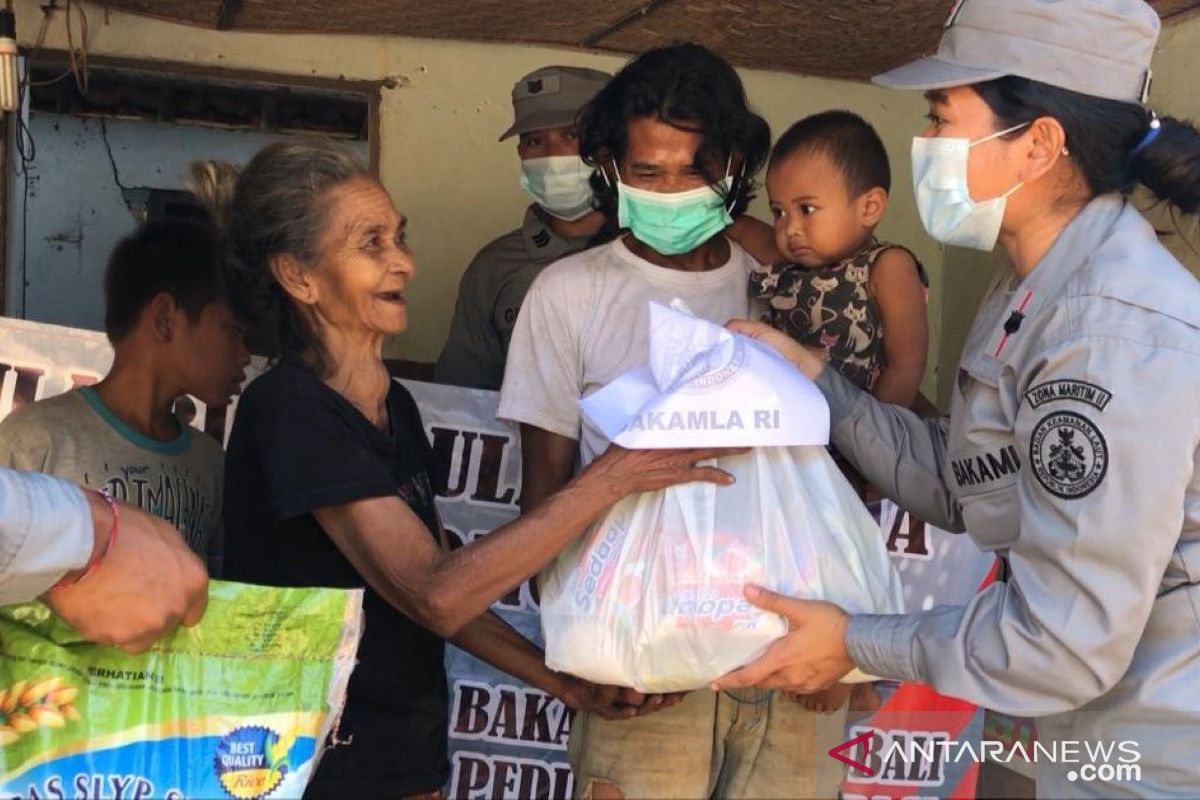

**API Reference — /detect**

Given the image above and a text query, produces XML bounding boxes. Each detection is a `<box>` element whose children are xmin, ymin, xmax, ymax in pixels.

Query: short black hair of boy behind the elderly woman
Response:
<box><xmin>104</xmin><ymin>219</ymin><xmax>228</xmax><ymax>344</ymax></box>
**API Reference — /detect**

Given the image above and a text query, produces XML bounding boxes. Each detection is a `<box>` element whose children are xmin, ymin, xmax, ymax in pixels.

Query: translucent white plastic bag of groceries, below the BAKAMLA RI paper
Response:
<box><xmin>541</xmin><ymin>446</ymin><xmax>901</xmax><ymax>692</ymax></box>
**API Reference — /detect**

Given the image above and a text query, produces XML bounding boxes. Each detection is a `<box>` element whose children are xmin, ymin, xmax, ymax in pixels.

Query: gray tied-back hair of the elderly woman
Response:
<box><xmin>192</xmin><ymin>138</ymin><xmax>374</xmax><ymax>372</ymax></box>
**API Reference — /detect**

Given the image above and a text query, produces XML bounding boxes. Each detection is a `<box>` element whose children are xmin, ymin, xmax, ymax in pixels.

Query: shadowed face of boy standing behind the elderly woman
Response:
<box><xmin>170</xmin><ymin>302</ymin><xmax>250</xmax><ymax>407</ymax></box>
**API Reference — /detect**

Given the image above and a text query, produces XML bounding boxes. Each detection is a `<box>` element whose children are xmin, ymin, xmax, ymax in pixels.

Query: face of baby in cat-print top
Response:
<box><xmin>767</xmin><ymin>150</ymin><xmax>871</xmax><ymax>267</ymax></box>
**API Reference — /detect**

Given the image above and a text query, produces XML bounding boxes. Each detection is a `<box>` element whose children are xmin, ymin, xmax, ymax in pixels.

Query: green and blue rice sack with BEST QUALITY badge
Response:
<box><xmin>0</xmin><ymin>581</ymin><xmax>362</xmax><ymax>800</ymax></box>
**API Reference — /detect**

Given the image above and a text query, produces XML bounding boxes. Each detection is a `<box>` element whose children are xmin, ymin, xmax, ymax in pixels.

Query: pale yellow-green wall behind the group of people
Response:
<box><xmin>17</xmin><ymin>0</ymin><xmax>941</xmax><ymax>389</ymax></box>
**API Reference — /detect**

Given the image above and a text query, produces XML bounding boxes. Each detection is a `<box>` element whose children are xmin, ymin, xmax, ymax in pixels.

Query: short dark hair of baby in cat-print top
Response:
<box><xmin>767</xmin><ymin>112</ymin><xmax>892</xmax><ymax>198</ymax></box>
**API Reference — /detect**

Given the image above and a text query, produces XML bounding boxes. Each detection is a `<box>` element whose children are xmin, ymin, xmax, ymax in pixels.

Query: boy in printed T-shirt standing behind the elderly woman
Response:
<box><xmin>0</xmin><ymin>221</ymin><xmax>250</xmax><ymax>573</ymax></box>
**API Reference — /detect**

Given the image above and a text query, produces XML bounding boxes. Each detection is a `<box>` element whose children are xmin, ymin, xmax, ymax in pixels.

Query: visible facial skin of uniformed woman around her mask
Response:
<box><xmin>920</xmin><ymin>86</ymin><xmax>1021</xmax><ymax>200</ymax></box>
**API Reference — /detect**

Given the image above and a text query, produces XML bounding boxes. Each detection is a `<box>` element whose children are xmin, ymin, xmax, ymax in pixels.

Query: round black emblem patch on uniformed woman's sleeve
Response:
<box><xmin>1030</xmin><ymin>411</ymin><xmax>1109</xmax><ymax>500</ymax></box>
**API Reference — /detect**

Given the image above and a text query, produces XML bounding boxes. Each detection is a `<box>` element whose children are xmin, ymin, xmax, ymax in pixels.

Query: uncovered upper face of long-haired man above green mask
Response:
<box><xmin>619</xmin><ymin>116</ymin><xmax>725</xmax><ymax>194</ymax></box>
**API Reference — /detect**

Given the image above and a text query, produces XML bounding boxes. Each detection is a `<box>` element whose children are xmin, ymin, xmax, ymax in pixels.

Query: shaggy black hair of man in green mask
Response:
<box><xmin>578</xmin><ymin>44</ymin><xmax>770</xmax><ymax>234</ymax></box>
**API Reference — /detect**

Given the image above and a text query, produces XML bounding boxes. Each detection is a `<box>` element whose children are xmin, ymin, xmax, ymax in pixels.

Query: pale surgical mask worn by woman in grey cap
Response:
<box><xmin>912</xmin><ymin>122</ymin><xmax>1030</xmax><ymax>251</ymax></box>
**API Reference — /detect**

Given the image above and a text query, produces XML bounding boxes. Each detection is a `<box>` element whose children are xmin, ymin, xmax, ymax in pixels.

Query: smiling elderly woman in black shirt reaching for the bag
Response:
<box><xmin>199</xmin><ymin>142</ymin><xmax>731</xmax><ymax>796</ymax></box>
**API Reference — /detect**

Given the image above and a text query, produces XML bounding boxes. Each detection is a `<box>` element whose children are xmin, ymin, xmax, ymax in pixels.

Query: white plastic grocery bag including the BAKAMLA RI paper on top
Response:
<box><xmin>541</xmin><ymin>303</ymin><xmax>902</xmax><ymax>692</ymax></box>
